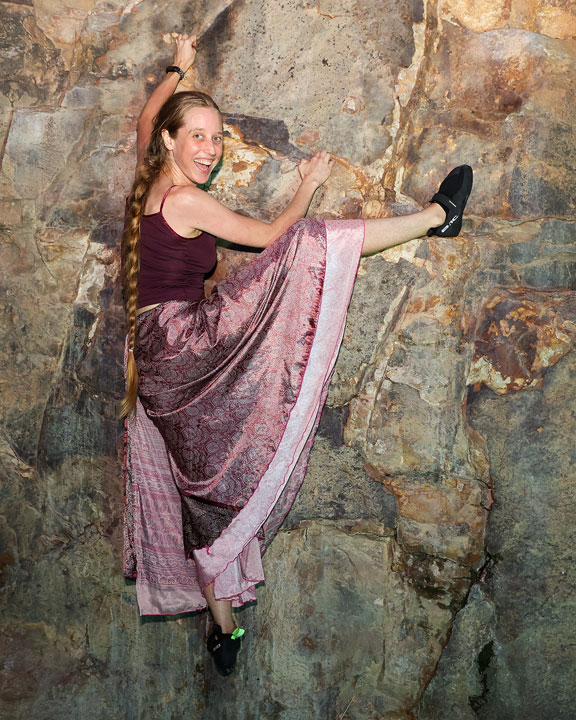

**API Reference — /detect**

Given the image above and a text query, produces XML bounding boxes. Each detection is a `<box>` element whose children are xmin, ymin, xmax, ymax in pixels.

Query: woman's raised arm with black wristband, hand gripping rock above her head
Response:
<box><xmin>136</xmin><ymin>33</ymin><xmax>198</xmax><ymax>165</ymax></box>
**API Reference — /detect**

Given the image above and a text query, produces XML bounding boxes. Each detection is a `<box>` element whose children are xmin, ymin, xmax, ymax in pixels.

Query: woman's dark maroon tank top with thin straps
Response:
<box><xmin>138</xmin><ymin>185</ymin><xmax>216</xmax><ymax>307</ymax></box>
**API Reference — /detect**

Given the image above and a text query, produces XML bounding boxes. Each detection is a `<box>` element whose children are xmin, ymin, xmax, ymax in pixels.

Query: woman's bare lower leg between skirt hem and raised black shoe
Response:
<box><xmin>362</xmin><ymin>203</ymin><xmax>446</xmax><ymax>255</ymax></box>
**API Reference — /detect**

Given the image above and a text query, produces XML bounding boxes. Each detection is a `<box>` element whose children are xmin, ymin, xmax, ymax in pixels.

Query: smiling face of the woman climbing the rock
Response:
<box><xmin>162</xmin><ymin>107</ymin><xmax>222</xmax><ymax>185</ymax></box>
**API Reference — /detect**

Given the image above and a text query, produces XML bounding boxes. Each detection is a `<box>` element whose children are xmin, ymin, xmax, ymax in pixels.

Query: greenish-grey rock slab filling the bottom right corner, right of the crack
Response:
<box><xmin>418</xmin><ymin>353</ymin><xmax>576</xmax><ymax>720</ymax></box>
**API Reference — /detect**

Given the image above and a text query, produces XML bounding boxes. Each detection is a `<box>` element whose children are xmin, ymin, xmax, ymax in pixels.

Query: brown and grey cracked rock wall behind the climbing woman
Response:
<box><xmin>0</xmin><ymin>0</ymin><xmax>576</xmax><ymax>720</ymax></box>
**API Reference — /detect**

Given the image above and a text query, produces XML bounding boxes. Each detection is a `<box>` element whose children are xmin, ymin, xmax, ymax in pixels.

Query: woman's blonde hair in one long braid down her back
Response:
<box><xmin>120</xmin><ymin>91</ymin><xmax>220</xmax><ymax>417</ymax></box>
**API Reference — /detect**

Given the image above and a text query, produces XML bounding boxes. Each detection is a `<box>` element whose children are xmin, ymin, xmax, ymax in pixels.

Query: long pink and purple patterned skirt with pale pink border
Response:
<box><xmin>124</xmin><ymin>220</ymin><xmax>364</xmax><ymax>615</ymax></box>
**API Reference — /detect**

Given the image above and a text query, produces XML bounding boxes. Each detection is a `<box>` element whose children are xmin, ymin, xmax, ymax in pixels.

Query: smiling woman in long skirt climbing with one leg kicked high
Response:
<box><xmin>122</xmin><ymin>36</ymin><xmax>472</xmax><ymax>675</ymax></box>
